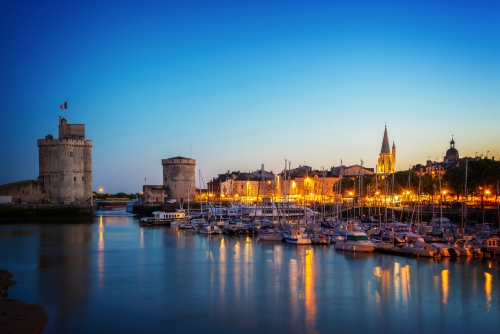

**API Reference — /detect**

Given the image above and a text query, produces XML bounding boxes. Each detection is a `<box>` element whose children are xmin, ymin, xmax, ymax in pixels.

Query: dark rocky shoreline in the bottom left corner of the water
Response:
<box><xmin>0</xmin><ymin>270</ymin><xmax>48</xmax><ymax>334</ymax></box>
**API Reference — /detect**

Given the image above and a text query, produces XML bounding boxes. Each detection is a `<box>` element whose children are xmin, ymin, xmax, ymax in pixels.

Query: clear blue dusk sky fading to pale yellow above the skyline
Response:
<box><xmin>0</xmin><ymin>0</ymin><xmax>500</xmax><ymax>193</ymax></box>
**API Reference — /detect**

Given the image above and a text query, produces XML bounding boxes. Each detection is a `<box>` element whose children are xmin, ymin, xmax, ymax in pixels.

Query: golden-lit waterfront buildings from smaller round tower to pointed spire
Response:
<box><xmin>142</xmin><ymin>127</ymin><xmax>396</xmax><ymax>204</ymax></box>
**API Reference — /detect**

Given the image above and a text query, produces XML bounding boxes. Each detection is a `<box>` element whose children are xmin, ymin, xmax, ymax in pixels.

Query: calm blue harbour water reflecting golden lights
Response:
<box><xmin>0</xmin><ymin>216</ymin><xmax>500</xmax><ymax>334</ymax></box>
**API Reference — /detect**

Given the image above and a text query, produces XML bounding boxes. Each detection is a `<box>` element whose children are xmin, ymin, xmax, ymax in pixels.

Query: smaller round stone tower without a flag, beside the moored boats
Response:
<box><xmin>161</xmin><ymin>157</ymin><xmax>196</xmax><ymax>202</ymax></box>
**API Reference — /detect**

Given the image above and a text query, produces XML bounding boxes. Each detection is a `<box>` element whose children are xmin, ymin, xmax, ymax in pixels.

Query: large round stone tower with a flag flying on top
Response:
<box><xmin>38</xmin><ymin>116</ymin><xmax>92</xmax><ymax>203</ymax></box>
